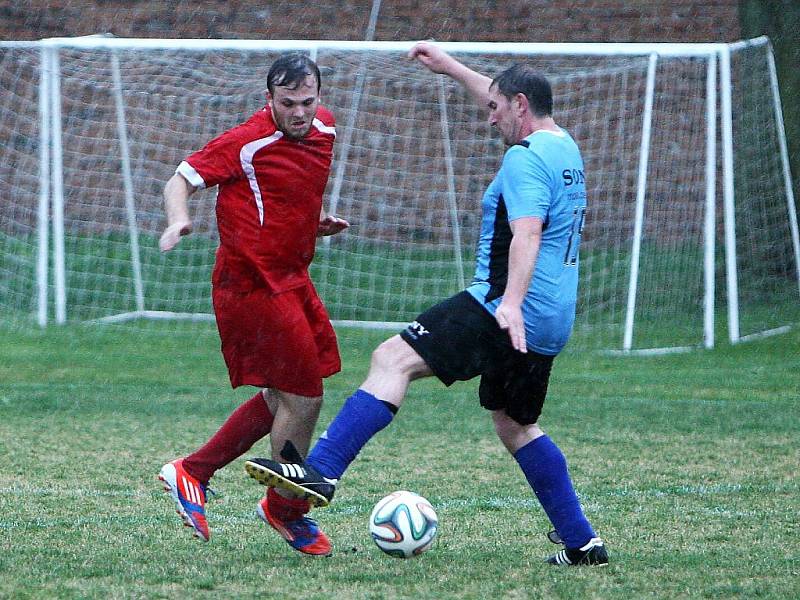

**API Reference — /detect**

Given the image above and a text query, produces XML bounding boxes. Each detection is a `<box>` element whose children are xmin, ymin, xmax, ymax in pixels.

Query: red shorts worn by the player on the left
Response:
<box><xmin>212</xmin><ymin>281</ymin><xmax>342</xmax><ymax>397</ymax></box>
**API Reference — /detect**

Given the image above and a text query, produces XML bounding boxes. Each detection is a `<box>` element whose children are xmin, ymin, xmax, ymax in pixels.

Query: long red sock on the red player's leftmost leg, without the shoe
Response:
<box><xmin>183</xmin><ymin>391</ymin><xmax>274</xmax><ymax>484</ymax></box>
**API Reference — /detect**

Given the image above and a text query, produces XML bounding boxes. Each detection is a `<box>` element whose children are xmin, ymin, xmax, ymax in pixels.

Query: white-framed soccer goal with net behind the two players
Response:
<box><xmin>0</xmin><ymin>36</ymin><xmax>800</xmax><ymax>352</ymax></box>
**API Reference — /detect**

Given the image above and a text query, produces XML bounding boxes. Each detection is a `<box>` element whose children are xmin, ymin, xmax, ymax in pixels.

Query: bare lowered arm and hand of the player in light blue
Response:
<box><xmin>495</xmin><ymin>217</ymin><xmax>542</xmax><ymax>352</ymax></box>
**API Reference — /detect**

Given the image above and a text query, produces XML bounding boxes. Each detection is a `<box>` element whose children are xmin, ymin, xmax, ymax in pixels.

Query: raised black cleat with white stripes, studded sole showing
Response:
<box><xmin>244</xmin><ymin>440</ymin><xmax>336</xmax><ymax>506</ymax></box>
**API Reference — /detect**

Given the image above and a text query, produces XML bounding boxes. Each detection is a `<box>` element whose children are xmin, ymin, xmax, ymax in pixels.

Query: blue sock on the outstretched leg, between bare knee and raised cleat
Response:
<box><xmin>306</xmin><ymin>390</ymin><xmax>394</xmax><ymax>479</ymax></box>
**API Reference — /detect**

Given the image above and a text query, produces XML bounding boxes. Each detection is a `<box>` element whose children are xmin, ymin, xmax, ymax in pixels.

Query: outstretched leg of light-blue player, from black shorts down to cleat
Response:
<box><xmin>245</xmin><ymin>292</ymin><xmax>494</xmax><ymax>506</ymax></box>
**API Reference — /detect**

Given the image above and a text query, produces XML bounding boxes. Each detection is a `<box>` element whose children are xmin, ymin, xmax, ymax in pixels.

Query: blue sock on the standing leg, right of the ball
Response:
<box><xmin>514</xmin><ymin>435</ymin><xmax>595</xmax><ymax>549</ymax></box>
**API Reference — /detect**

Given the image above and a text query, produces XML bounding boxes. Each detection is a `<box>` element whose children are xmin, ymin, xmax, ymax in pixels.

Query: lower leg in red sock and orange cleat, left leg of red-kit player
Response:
<box><xmin>158</xmin><ymin>391</ymin><xmax>274</xmax><ymax>542</ymax></box>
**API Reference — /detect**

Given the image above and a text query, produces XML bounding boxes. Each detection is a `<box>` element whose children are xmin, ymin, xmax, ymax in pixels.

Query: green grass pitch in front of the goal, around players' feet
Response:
<box><xmin>0</xmin><ymin>324</ymin><xmax>800</xmax><ymax>599</ymax></box>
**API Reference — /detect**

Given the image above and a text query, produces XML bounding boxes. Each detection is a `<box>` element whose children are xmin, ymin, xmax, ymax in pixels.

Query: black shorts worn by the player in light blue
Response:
<box><xmin>400</xmin><ymin>292</ymin><xmax>555</xmax><ymax>425</ymax></box>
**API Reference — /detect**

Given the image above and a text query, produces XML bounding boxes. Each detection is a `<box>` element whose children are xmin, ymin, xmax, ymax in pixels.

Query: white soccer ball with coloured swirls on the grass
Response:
<box><xmin>369</xmin><ymin>491</ymin><xmax>439</xmax><ymax>558</ymax></box>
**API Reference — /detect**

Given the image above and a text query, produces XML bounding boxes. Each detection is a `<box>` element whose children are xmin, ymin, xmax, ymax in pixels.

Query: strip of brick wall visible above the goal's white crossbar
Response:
<box><xmin>0</xmin><ymin>0</ymin><xmax>741</xmax><ymax>42</ymax></box>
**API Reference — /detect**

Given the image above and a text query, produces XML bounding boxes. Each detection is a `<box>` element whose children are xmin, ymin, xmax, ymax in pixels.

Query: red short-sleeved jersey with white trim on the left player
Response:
<box><xmin>177</xmin><ymin>106</ymin><xmax>336</xmax><ymax>293</ymax></box>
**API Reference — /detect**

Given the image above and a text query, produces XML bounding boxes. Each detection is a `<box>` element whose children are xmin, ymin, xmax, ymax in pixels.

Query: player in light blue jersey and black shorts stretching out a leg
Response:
<box><xmin>245</xmin><ymin>42</ymin><xmax>608</xmax><ymax>565</ymax></box>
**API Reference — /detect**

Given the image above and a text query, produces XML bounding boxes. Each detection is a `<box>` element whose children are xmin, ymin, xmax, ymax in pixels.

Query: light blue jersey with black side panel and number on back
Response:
<box><xmin>467</xmin><ymin>129</ymin><xmax>586</xmax><ymax>355</ymax></box>
